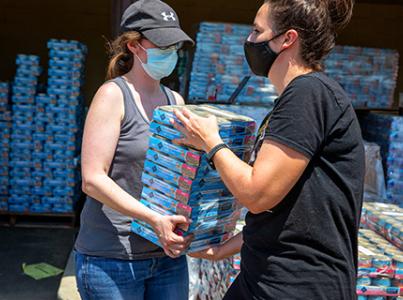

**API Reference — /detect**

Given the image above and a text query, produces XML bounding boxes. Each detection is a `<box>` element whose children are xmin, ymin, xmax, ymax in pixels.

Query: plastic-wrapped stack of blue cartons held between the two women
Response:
<box><xmin>132</xmin><ymin>105</ymin><xmax>256</xmax><ymax>252</ymax></box>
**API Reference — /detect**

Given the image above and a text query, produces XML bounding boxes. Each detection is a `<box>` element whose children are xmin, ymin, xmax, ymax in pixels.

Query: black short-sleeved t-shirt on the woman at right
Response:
<box><xmin>234</xmin><ymin>72</ymin><xmax>365</xmax><ymax>300</ymax></box>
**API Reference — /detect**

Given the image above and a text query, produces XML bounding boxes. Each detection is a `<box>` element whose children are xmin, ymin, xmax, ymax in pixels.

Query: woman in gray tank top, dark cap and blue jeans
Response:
<box><xmin>75</xmin><ymin>0</ymin><xmax>193</xmax><ymax>300</ymax></box>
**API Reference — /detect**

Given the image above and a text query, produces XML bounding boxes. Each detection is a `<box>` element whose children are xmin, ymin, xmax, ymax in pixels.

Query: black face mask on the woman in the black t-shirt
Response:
<box><xmin>244</xmin><ymin>32</ymin><xmax>284</xmax><ymax>77</ymax></box>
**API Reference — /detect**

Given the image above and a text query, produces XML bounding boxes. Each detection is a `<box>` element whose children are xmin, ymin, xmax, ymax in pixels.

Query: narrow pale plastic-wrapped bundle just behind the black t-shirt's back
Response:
<box><xmin>364</xmin><ymin>143</ymin><xmax>386</xmax><ymax>199</ymax></box>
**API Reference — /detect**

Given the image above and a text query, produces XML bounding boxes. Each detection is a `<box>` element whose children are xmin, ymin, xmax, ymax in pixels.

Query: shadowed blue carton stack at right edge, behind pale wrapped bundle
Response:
<box><xmin>360</xmin><ymin>113</ymin><xmax>403</xmax><ymax>207</ymax></box>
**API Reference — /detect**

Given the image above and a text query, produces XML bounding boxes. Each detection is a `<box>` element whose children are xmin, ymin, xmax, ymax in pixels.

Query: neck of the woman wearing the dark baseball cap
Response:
<box><xmin>125</xmin><ymin>59</ymin><xmax>161</xmax><ymax>94</ymax></box>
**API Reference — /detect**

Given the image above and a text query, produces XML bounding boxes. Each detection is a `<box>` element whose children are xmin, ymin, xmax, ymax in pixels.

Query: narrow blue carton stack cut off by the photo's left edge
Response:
<box><xmin>0</xmin><ymin>82</ymin><xmax>11</xmax><ymax>211</ymax></box>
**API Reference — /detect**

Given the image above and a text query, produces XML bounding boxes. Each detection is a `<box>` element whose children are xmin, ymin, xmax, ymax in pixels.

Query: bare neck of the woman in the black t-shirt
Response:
<box><xmin>269</xmin><ymin>54</ymin><xmax>314</xmax><ymax>95</ymax></box>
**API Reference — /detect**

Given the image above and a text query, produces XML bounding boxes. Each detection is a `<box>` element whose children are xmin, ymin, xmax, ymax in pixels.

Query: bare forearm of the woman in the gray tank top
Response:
<box><xmin>83</xmin><ymin>174</ymin><xmax>159</xmax><ymax>226</ymax></box>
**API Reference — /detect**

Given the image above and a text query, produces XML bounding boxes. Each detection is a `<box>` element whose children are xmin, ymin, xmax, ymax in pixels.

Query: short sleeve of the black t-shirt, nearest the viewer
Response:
<box><xmin>265</xmin><ymin>77</ymin><xmax>329</xmax><ymax>159</ymax></box>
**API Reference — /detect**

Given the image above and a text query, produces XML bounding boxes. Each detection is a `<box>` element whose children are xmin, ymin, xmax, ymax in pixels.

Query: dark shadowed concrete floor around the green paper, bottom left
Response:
<box><xmin>0</xmin><ymin>227</ymin><xmax>76</xmax><ymax>300</ymax></box>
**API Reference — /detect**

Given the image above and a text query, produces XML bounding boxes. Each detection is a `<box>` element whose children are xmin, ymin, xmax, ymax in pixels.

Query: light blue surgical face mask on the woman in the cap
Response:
<box><xmin>137</xmin><ymin>44</ymin><xmax>178</xmax><ymax>80</ymax></box>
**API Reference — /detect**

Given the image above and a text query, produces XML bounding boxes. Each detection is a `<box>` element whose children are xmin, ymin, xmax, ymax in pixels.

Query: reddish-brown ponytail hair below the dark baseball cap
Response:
<box><xmin>106</xmin><ymin>31</ymin><xmax>141</xmax><ymax>80</ymax></box>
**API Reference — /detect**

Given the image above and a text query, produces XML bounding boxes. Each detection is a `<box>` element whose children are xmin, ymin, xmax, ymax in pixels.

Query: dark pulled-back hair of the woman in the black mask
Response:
<box><xmin>265</xmin><ymin>0</ymin><xmax>354</xmax><ymax>71</ymax></box>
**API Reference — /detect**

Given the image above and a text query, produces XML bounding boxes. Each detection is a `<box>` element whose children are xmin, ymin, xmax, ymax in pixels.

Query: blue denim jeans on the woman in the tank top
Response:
<box><xmin>75</xmin><ymin>251</ymin><xmax>189</xmax><ymax>300</ymax></box>
